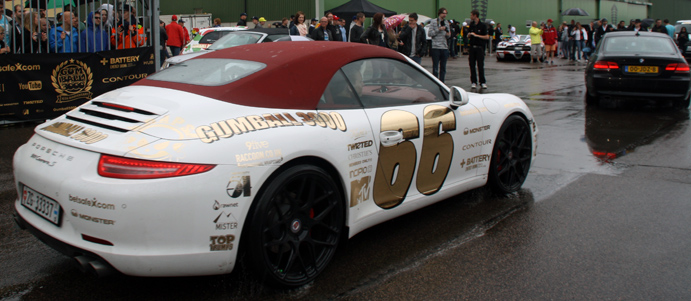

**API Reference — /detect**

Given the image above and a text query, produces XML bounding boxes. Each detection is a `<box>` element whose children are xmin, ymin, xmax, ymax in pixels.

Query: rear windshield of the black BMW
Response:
<box><xmin>604</xmin><ymin>35</ymin><xmax>676</xmax><ymax>54</ymax></box>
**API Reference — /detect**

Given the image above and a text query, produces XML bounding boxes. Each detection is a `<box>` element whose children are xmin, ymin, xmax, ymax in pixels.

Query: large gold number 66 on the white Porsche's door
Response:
<box><xmin>373</xmin><ymin>105</ymin><xmax>456</xmax><ymax>209</ymax></box>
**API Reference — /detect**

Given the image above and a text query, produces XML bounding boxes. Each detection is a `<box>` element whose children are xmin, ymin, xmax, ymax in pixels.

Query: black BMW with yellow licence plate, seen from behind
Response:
<box><xmin>585</xmin><ymin>31</ymin><xmax>691</xmax><ymax>108</ymax></box>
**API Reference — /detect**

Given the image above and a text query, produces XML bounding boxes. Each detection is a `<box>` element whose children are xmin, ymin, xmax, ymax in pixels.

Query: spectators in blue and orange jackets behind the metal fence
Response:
<box><xmin>0</xmin><ymin>1</ymin><xmax>153</xmax><ymax>54</ymax></box>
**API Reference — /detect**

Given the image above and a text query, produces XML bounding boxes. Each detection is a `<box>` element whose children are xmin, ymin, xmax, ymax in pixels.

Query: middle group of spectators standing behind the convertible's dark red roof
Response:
<box><xmin>237</xmin><ymin>7</ymin><xmax>503</xmax><ymax>89</ymax></box>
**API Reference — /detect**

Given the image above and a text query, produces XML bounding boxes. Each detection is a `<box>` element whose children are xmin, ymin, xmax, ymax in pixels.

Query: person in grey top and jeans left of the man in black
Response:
<box><xmin>427</xmin><ymin>7</ymin><xmax>451</xmax><ymax>82</ymax></box>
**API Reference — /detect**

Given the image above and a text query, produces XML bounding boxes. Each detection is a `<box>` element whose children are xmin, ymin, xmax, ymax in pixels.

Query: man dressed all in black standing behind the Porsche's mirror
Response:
<box><xmin>468</xmin><ymin>9</ymin><xmax>489</xmax><ymax>89</ymax></box>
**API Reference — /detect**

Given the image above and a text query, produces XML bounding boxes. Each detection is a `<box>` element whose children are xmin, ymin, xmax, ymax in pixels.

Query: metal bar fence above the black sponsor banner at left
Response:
<box><xmin>0</xmin><ymin>0</ymin><xmax>160</xmax><ymax>66</ymax></box>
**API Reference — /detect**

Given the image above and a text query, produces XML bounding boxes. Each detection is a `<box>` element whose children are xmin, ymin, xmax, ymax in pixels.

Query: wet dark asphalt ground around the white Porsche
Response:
<box><xmin>0</xmin><ymin>52</ymin><xmax>691</xmax><ymax>300</ymax></box>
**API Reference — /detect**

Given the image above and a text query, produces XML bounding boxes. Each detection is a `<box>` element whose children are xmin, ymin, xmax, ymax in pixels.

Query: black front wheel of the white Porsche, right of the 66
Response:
<box><xmin>488</xmin><ymin>115</ymin><xmax>533</xmax><ymax>194</ymax></box>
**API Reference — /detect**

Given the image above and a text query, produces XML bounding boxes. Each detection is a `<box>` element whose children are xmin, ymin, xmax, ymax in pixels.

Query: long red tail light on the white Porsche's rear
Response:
<box><xmin>98</xmin><ymin>155</ymin><xmax>216</xmax><ymax>179</ymax></box>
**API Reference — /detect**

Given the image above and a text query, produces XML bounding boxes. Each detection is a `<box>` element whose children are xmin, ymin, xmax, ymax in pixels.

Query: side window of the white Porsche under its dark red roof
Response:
<box><xmin>343</xmin><ymin>59</ymin><xmax>448</xmax><ymax>108</ymax></box>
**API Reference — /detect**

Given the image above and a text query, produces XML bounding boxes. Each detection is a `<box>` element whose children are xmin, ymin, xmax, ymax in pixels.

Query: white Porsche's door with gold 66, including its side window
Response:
<box><xmin>342</xmin><ymin>58</ymin><xmax>482</xmax><ymax>210</ymax></box>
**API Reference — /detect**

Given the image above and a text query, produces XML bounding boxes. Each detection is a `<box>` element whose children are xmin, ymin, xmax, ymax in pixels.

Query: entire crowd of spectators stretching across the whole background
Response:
<box><xmin>0</xmin><ymin>1</ymin><xmax>689</xmax><ymax>88</ymax></box>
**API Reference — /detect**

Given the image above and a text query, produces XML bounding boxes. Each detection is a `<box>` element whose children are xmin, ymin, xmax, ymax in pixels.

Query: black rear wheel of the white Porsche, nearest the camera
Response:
<box><xmin>242</xmin><ymin>165</ymin><xmax>345</xmax><ymax>288</ymax></box>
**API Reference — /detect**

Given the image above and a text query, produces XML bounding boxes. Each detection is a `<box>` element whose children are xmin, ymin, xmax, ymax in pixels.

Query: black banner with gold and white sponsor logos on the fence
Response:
<box><xmin>0</xmin><ymin>47</ymin><xmax>156</xmax><ymax>121</ymax></box>
